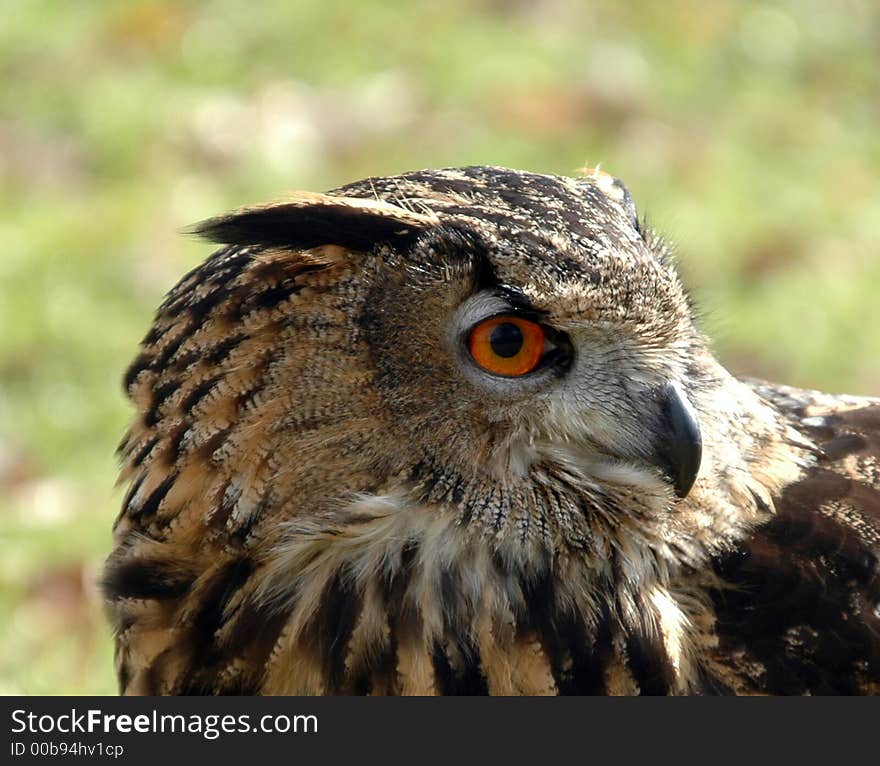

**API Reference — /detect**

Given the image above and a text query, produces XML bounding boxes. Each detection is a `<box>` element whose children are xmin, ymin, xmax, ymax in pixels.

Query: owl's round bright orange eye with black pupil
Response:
<box><xmin>468</xmin><ymin>315</ymin><xmax>544</xmax><ymax>377</ymax></box>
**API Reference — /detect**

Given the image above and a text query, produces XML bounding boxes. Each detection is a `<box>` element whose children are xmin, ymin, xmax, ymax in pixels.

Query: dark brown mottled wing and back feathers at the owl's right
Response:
<box><xmin>710</xmin><ymin>384</ymin><xmax>880</xmax><ymax>694</ymax></box>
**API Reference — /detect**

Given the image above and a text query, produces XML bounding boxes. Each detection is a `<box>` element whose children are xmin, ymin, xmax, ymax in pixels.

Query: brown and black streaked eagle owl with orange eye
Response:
<box><xmin>103</xmin><ymin>167</ymin><xmax>880</xmax><ymax>695</ymax></box>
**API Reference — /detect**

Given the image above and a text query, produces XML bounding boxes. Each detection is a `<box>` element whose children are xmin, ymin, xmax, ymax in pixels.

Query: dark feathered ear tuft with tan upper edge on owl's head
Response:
<box><xmin>190</xmin><ymin>193</ymin><xmax>439</xmax><ymax>252</ymax></box>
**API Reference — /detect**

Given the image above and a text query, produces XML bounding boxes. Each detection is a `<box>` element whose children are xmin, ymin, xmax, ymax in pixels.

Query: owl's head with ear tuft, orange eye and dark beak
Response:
<box><xmin>118</xmin><ymin>167</ymin><xmax>796</xmax><ymax>576</ymax></box>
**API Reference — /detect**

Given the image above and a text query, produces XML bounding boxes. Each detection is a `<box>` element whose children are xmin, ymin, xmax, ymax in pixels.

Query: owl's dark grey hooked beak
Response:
<box><xmin>650</xmin><ymin>384</ymin><xmax>703</xmax><ymax>498</ymax></box>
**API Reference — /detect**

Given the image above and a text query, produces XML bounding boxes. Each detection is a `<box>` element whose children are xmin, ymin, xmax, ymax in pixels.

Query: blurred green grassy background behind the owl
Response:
<box><xmin>0</xmin><ymin>0</ymin><xmax>880</xmax><ymax>694</ymax></box>
